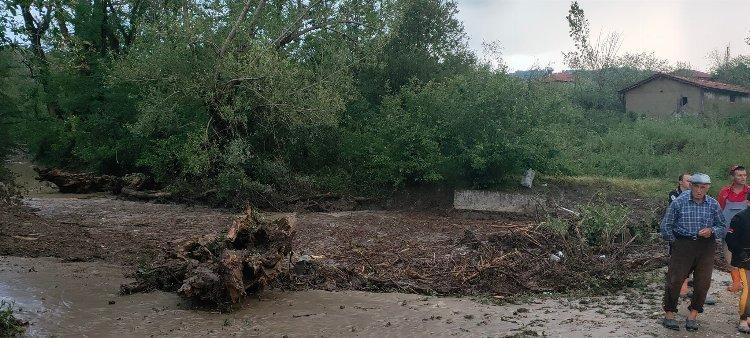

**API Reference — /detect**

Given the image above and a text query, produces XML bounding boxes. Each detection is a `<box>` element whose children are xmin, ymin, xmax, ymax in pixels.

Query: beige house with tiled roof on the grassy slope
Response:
<box><xmin>619</xmin><ymin>73</ymin><xmax>750</xmax><ymax>117</ymax></box>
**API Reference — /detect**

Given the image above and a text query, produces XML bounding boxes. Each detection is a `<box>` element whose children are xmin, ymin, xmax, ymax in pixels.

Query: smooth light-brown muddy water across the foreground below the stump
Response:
<box><xmin>0</xmin><ymin>257</ymin><xmax>668</xmax><ymax>337</ymax></box>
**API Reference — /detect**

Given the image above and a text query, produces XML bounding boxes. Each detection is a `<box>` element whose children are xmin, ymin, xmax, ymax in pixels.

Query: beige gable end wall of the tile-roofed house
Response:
<box><xmin>625</xmin><ymin>78</ymin><xmax>702</xmax><ymax>117</ymax></box>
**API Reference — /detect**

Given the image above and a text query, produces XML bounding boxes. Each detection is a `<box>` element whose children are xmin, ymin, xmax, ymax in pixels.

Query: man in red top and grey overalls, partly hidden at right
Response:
<box><xmin>716</xmin><ymin>165</ymin><xmax>750</xmax><ymax>292</ymax></box>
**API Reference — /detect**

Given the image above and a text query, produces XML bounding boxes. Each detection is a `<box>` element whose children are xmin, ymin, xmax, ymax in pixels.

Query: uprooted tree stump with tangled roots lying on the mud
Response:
<box><xmin>121</xmin><ymin>208</ymin><xmax>294</xmax><ymax>307</ymax></box>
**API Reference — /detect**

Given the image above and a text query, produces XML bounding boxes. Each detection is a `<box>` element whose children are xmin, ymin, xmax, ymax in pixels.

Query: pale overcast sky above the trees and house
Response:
<box><xmin>457</xmin><ymin>0</ymin><xmax>750</xmax><ymax>71</ymax></box>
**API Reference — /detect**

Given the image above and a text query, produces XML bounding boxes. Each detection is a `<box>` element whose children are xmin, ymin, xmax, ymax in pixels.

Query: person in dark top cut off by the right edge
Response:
<box><xmin>725</xmin><ymin>209</ymin><xmax>750</xmax><ymax>333</ymax></box>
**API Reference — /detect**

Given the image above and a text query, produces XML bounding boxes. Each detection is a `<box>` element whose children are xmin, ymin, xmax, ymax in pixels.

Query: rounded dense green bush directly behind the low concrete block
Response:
<box><xmin>343</xmin><ymin>69</ymin><xmax>575</xmax><ymax>186</ymax></box>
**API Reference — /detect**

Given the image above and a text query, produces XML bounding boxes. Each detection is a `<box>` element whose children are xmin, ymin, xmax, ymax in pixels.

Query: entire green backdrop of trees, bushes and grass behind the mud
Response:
<box><xmin>0</xmin><ymin>0</ymin><xmax>750</xmax><ymax>208</ymax></box>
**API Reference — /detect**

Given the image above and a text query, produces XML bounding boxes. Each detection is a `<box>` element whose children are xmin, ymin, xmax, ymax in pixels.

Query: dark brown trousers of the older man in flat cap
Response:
<box><xmin>664</xmin><ymin>237</ymin><xmax>716</xmax><ymax>312</ymax></box>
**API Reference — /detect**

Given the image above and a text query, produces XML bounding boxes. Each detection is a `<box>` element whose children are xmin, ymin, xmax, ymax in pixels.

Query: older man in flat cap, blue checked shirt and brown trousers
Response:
<box><xmin>661</xmin><ymin>173</ymin><xmax>726</xmax><ymax>331</ymax></box>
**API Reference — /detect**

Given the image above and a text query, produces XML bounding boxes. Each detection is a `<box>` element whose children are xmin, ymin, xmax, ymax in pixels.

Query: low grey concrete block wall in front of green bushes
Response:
<box><xmin>453</xmin><ymin>190</ymin><xmax>546</xmax><ymax>214</ymax></box>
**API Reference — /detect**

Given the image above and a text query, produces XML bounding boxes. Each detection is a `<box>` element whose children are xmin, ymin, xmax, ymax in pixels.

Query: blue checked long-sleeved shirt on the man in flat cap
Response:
<box><xmin>661</xmin><ymin>190</ymin><xmax>727</xmax><ymax>242</ymax></box>
